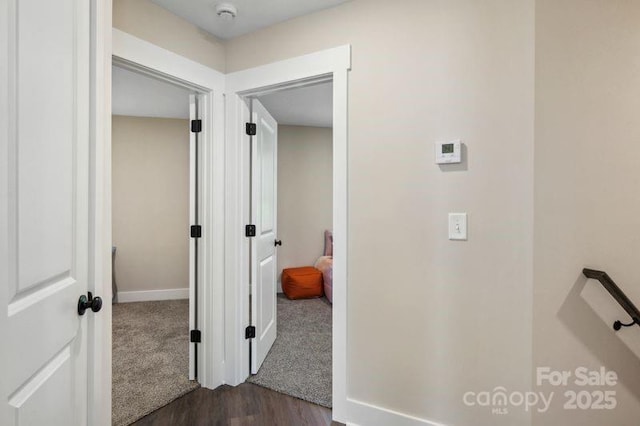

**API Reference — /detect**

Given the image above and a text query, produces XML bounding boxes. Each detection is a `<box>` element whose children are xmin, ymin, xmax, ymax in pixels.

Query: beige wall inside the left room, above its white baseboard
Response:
<box><xmin>112</xmin><ymin>116</ymin><xmax>189</xmax><ymax>292</ymax></box>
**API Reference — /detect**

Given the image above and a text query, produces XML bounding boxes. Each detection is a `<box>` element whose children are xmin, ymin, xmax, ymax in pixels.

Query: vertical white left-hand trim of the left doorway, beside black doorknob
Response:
<box><xmin>87</xmin><ymin>0</ymin><xmax>113</xmax><ymax>426</ymax></box>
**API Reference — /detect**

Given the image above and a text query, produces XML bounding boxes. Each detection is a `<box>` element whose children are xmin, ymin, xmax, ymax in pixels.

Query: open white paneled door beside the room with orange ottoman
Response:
<box><xmin>251</xmin><ymin>99</ymin><xmax>278</xmax><ymax>374</ymax></box>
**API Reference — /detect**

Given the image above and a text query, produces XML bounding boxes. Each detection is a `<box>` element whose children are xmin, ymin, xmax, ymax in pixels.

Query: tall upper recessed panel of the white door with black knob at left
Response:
<box><xmin>15</xmin><ymin>0</ymin><xmax>77</xmax><ymax>291</ymax></box>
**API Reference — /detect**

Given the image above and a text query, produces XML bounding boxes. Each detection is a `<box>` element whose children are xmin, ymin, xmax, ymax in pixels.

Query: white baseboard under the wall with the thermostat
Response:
<box><xmin>347</xmin><ymin>398</ymin><xmax>446</xmax><ymax>426</ymax></box>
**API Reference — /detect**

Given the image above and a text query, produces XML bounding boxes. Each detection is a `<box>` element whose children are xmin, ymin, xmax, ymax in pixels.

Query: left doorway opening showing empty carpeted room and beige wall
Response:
<box><xmin>111</xmin><ymin>64</ymin><xmax>199</xmax><ymax>425</ymax></box>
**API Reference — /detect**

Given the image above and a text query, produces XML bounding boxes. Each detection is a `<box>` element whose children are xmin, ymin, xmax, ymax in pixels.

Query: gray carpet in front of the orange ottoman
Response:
<box><xmin>247</xmin><ymin>294</ymin><xmax>332</xmax><ymax>408</ymax></box>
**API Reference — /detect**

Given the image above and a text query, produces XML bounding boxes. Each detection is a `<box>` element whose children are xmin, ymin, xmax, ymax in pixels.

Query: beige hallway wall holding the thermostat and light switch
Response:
<box><xmin>227</xmin><ymin>0</ymin><xmax>534</xmax><ymax>426</ymax></box>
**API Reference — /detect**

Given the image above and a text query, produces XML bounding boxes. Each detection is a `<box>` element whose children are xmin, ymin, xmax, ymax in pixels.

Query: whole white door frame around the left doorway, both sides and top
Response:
<box><xmin>90</xmin><ymin>26</ymin><xmax>224</xmax><ymax>424</ymax></box>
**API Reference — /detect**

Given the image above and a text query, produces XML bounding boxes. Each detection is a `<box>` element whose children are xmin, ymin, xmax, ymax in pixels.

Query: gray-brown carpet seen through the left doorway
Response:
<box><xmin>112</xmin><ymin>300</ymin><xmax>200</xmax><ymax>426</ymax></box>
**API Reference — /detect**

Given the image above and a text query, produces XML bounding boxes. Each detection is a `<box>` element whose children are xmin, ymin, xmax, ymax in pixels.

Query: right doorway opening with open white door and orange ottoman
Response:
<box><xmin>244</xmin><ymin>79</ymin><xmax>333</xmax><ymax>408</ymax></box>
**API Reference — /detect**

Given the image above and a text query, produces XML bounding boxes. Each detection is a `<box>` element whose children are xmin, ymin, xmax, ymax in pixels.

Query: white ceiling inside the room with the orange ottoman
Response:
<box><xmin>259</xmin><ymin>83</ymin><xmax>333</xmax><ymax>127</ymax></box>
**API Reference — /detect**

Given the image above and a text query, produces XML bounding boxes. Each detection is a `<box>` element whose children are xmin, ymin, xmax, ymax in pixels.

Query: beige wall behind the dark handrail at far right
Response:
<box><xmin>534</xmin><ymin>0</ymin><xmax>640</xmax><ymax>426</ymax></box>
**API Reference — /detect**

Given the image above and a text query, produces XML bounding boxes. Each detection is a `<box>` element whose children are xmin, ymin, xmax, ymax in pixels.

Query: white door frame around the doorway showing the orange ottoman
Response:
<box><xmin>225</xmin><ymin>45</ymin><xmax>351</xmax><ymax>422</ymax></box>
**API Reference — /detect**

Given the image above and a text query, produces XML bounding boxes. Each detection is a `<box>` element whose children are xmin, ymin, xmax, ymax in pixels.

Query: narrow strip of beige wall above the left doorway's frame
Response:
<box><xmin>113</xmin><ymin>0</ymin><xmax>225</xmax><ymax>72</ymax></box>
